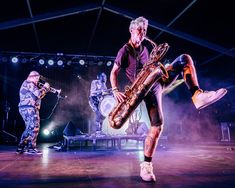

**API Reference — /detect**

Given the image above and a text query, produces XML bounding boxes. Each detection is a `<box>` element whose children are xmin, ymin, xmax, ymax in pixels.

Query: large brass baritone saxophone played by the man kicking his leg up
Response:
<box><xmin>108</xmin><ymin>37</ymin><xmax>169</xmax><ymax>129</ymax></box>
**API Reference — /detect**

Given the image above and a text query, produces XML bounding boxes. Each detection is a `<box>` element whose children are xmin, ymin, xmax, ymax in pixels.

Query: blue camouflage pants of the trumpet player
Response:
<box><xmin>19</xmin><ymin>108</ymin><xmax>40</xmax><ymax>148</ymax></box>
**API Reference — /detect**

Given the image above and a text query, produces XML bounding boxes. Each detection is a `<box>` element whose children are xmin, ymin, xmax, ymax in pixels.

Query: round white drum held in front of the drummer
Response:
<box><xmin>99</xmin><ymin>95</ymin><xmax>117</xmax><ymax>117</ymax></box>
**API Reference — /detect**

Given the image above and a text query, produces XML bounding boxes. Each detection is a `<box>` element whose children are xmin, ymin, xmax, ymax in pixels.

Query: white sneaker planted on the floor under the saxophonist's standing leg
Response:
<box><xmin>140</xmin><ymin>161</ymin><xmax>156</xmax><ymax>181</ymax></box>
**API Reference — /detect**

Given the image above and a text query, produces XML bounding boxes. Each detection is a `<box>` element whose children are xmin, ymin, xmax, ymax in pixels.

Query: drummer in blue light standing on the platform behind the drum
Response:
<box><xmin>89</xmin><ymin>72</ymin><xmax>108</xmax><ymax>136</ymax></box>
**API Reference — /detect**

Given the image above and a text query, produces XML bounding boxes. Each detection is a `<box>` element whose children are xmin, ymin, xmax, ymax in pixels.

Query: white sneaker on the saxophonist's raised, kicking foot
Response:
<box><xmin>192</xmin><ymin>88</ymin><xmax>227</xmax><ymax>110</ymax></box>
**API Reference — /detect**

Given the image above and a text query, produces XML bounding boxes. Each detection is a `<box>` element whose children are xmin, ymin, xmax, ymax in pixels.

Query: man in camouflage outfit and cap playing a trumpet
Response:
<box><xmin>16</xmin><ymin>71</ymin><xmax>50</xmax><ymax>155</ymax></box>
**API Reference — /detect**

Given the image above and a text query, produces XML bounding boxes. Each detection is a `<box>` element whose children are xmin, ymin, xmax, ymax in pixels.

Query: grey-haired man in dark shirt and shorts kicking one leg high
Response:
<box><xmin>110</xmin><ymin>17</ymin><xmax>227</xmax><ymax>181</ymax></box>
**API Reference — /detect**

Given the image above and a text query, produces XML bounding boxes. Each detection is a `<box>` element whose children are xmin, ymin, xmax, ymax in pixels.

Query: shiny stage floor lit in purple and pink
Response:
<box><xmin>0</xmin><ymin>142</ymin><xmax>235</xmax><ymax>188</ymax></box>
